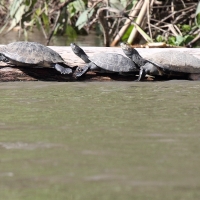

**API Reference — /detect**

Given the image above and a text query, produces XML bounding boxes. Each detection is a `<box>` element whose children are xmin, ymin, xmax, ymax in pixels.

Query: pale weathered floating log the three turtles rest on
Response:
<box><xmin>0</xmin><ymin>46</ymin><xmax>200</xmax><ymax>81</ymax></box>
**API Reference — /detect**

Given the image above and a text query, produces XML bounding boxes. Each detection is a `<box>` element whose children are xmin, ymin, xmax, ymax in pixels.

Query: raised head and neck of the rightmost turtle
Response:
<box><xmin>120</xmin><ymin>42</ymin><xmax>146</xmax><ymax>67</ymax></box>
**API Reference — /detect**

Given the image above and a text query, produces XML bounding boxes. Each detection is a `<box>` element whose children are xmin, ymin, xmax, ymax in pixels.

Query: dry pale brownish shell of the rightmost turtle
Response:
<box><xmin>141</xmin><ymin>50</ymin><xmax>200</xmax><ymax>73</ymax></box>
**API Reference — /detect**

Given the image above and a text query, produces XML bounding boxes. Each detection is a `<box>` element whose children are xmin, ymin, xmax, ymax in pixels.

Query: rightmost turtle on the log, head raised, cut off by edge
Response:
<box><xmin>120</xmin><ymin>43</ymin><xmax>200</xmax><ymax>81</ymax></box>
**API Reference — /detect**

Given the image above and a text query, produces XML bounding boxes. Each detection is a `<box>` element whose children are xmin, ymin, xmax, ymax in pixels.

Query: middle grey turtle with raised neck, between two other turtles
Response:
<box><xmin>71</xmin><ymin>43</ymin><xmax>139</xmax><ymax>78</ymax></box>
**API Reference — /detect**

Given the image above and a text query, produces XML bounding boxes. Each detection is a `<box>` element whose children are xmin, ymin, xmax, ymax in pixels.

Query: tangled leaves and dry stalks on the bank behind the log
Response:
<box><xmin>0</xmin><ymin>0</ymin><xmax>200</xmax><ymax>47</ymax></box>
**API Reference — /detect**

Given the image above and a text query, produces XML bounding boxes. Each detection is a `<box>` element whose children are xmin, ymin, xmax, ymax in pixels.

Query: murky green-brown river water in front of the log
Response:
<box><xmin>0</xmin><ymin>81</ymin><xmax>200</xmax><ymax>200</ymax></box>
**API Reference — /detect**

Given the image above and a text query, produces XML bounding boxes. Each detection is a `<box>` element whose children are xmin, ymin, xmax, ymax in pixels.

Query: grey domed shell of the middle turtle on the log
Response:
<box><xmin>89</xmin><ymin>53</ymin><xmax>138</xmax><ymax>72</ymax></box>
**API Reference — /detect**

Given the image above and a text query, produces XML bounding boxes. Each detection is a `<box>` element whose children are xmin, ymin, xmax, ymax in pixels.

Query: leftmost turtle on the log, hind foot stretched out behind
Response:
<box><xmin>0</xmin><ymin>42</ymin><xmax>72</xmax><ymax>74</ymax></box>
